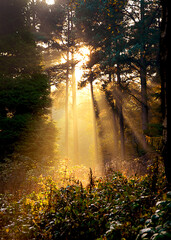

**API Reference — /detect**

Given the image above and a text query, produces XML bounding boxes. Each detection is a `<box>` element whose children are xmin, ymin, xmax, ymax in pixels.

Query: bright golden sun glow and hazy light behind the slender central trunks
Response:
<box><xmin>52</xmin><ymin>47</ymin><xmax>101</xmax><ymax>172</ymax></box>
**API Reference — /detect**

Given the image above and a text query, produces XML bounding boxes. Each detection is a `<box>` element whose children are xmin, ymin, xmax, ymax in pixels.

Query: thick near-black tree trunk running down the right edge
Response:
<box><xmin>160</xmin><ymin>0</ymin><xmax>171</xmax><ymax>187</ymax></box>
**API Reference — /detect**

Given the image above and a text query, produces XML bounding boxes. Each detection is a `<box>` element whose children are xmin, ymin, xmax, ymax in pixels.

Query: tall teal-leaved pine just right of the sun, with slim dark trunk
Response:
<box><xmin>76</xmin><ymin>1</ymin><xmax>127</xmax><ymax>163</ymax></box>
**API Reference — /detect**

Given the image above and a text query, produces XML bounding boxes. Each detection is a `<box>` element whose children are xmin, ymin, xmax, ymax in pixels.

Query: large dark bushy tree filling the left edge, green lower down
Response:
<box><xmin>0</xmin><ymin>0</ymin><xmax>50</xmax><ymax>160</ymax></box>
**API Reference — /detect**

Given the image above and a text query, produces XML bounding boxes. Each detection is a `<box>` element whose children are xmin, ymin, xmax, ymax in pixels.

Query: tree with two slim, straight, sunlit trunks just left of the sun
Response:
<box><xmin>38</xmin><ymin>0</ymin><xmax>79</xmax><ymax>163</ymax></box>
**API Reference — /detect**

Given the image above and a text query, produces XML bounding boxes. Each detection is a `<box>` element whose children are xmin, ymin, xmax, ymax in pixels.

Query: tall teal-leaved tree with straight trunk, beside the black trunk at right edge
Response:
<box><xmin>125</xmin><ymin>0</ymin><xmax>160</xmax><ymax>133</ymax></box>
